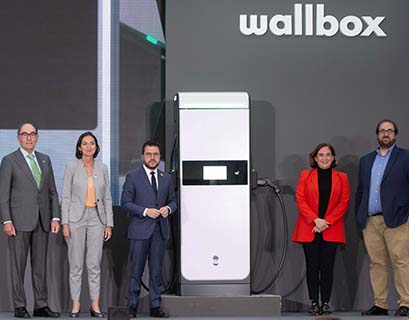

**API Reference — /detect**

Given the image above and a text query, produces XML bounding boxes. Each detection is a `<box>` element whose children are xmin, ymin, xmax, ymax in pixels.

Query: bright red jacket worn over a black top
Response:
<box><xmin>292</xmin><ymin>169</ymin><xmax>350</xmax><ymax>243</ymax></box>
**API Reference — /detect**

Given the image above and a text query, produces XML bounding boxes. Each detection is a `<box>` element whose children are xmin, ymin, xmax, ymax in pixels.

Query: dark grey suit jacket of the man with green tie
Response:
<box><xmin>0</xmin><ymin>149</ymin><xmax>60</xmax><ymax>232</ymax></box>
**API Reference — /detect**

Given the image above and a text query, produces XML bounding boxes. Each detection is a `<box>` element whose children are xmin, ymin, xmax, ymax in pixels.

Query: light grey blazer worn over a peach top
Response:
<box><xmin>61</xmin><ymin>159</ymin><xmax>114</xmax><ymax>227</ymax></box>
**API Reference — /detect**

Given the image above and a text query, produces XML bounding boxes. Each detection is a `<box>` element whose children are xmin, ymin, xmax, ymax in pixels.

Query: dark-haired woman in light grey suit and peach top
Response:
<box><xmin>61</xmin><ymin>131</ymin><xmax>113</xmax><ymax>318</ymax></box>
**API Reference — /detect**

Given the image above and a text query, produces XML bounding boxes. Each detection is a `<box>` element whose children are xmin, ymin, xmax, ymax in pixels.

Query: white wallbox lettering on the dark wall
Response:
<box><xmin>240</xmin><ymin>3</ymin><xmax>386</xmax><ymax>37</ymax></box>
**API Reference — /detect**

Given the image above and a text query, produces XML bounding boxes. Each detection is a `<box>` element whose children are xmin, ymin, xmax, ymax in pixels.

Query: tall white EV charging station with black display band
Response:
<box><xmin>174</xmin><ymin>92</ymin><xmax>250</xmax><ymax>295</ymax></box>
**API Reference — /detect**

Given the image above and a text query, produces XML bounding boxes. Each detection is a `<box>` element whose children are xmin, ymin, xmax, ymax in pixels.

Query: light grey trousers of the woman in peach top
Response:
<box><xmin>67</xmin><ymin>208</ymin><xmax>105</xmax><ymax>300</ymax></box>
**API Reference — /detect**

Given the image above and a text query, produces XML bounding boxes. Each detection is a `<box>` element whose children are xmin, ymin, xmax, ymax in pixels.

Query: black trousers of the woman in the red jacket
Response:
<box><xmin>303</xmin><ymin>233</ymin><xmax>338</xmax><ymax>303</ymax></box>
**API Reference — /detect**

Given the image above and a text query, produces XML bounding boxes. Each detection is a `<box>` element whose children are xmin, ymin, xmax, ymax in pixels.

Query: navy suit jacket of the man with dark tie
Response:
<box><xmin>121</xmin><ymin>166</ymin><xmax>177</xmax><ymax>240</ymax></box>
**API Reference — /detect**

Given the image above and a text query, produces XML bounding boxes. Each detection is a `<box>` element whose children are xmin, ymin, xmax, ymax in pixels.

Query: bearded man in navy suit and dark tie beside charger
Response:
<box><xmin>121</xmin><ymin>141</ymin><xmax>176</xmax><ymax>318</ymax></box>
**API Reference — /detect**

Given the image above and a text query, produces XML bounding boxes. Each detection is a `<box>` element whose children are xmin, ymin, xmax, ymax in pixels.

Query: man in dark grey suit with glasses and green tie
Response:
<box><xmin>0</xmin><ymin>123</ymin><xmax>60</xmax><ymax>318</ymax></box>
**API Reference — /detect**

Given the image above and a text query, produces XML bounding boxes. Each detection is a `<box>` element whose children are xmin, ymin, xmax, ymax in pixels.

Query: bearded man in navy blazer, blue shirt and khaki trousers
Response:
<box><xmin>355</xmin><ymin>120</ymin><xmax>409</xmax><ymax>316</ymax></box>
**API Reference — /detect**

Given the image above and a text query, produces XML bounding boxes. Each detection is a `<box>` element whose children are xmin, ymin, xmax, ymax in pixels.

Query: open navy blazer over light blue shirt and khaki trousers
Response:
<box><xmin>355</xmin><ymin>145</ymin><xmax>409</xmax><ymax>229</ymax></box>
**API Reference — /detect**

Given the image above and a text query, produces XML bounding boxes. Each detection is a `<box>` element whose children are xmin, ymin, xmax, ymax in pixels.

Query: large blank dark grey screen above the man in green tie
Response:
<box><xmin>0</xmin><ymin>0</ymin><xmax>98</xmax><ymax>130</ymax></box>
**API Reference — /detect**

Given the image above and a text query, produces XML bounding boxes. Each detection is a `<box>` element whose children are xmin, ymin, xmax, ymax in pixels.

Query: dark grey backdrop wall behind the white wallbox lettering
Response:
<box><xmin>166</xmin><ymin>0</ymin><xmax>409</xmax><ymax>310</ymax></box>
